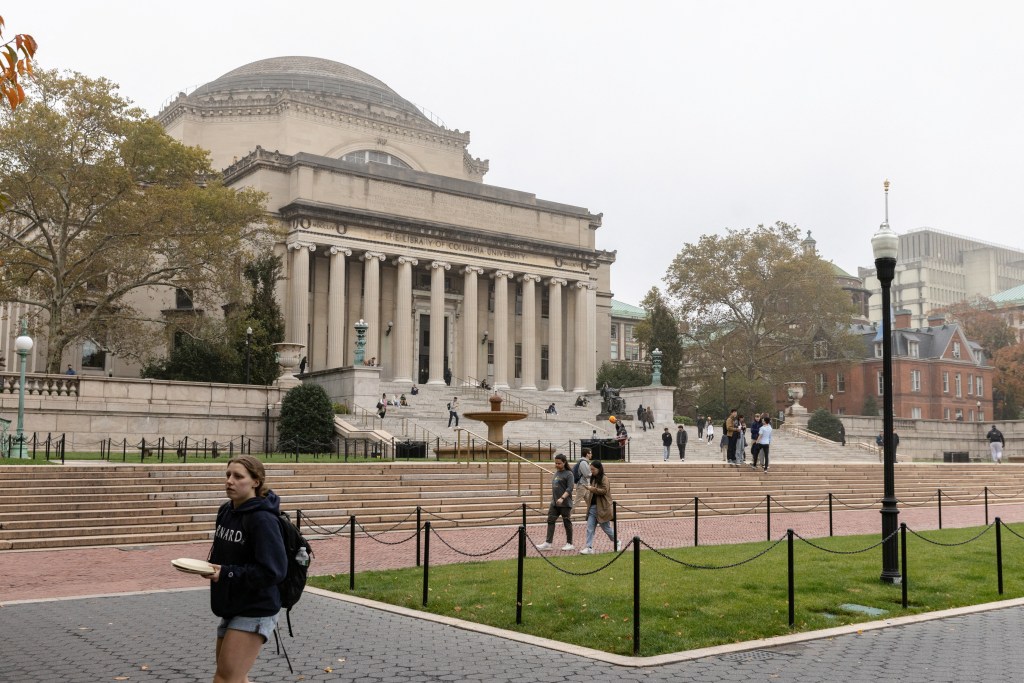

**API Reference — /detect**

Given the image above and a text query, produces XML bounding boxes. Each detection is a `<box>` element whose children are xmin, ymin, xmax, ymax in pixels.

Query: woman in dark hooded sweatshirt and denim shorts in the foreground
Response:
<box><xmin>206</xmin><ymin>456</ymin><xmax>288</xmax><ymax>683</ymax></box>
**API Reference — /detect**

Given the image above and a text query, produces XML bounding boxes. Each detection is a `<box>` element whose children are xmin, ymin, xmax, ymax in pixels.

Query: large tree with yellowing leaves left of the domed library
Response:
<box><xmin>0</xmin><ymin>71</ymin><xmax>264</xmax><ymax>373</ymax></box>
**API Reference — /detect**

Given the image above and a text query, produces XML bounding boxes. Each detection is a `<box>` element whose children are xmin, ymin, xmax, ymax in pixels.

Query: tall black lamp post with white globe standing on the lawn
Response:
<box><xmin>871</xmin><ymin>216</ymin><xmax>901</xmax><ymax>584</ymax></box>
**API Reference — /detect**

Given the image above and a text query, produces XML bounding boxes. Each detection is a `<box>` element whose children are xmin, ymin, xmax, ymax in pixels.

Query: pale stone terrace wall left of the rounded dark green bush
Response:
<box><xmin>0</xmin><ymin>373</ymin><xmax>282</xmax><ymax>451</ymax></box>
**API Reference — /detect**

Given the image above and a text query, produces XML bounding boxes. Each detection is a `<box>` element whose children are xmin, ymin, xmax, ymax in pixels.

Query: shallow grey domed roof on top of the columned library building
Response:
<box><xmin>189</xmin><ymin>56</ymin><xmax>426</xmax><ymax>120</ymax></box>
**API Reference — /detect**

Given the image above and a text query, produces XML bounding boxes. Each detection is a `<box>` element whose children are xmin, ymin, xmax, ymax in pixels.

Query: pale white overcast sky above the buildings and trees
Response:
<box><xmin>8</xmin><ymin>0</ymin><xmax>1024</xmax><ymax>303</ymax></box>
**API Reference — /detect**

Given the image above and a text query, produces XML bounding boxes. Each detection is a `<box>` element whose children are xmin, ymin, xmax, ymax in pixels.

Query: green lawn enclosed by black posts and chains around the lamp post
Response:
<box><xmin>309</xmin><ymin>524</ymin><xmax>1024</xmax><ymax>655</ymax></box>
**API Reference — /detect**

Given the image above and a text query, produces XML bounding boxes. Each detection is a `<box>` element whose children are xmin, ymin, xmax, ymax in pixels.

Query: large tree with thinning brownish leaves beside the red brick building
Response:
<box><xmin>665</xmin><ymin>222</ymin><xmax>856</xmax><ymax>411</ymax></box>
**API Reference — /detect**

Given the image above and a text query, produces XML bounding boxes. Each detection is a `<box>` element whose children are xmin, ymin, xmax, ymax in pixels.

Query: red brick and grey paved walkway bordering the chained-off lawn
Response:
<box><xmin>0</xmin><ymin>505</ymin><xmax>1024</xmax><ymax>683</ymax></box>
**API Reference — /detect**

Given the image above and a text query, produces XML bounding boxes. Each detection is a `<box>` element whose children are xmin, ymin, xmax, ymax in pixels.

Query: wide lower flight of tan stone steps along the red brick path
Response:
<box><xmin>0</xmin><ymin>458</ymin><xmax>1024</xmax><ymax>551</ymax></box>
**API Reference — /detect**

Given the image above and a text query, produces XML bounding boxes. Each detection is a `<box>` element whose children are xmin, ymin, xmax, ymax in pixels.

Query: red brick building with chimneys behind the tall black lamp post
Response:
<box><xmin>801</xmin><ymin>310</ymin><xmax>994</xmax><ymax>422</ymax></box>
